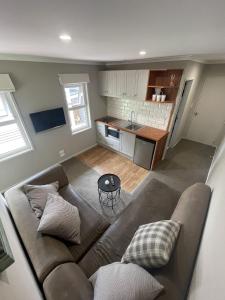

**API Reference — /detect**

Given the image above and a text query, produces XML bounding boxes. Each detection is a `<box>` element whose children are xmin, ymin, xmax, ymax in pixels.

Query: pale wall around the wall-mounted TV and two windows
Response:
<box><xmin>0</xmin><ymin>61</ymin><xmax>106</xmax><ymax>191</ymax></box>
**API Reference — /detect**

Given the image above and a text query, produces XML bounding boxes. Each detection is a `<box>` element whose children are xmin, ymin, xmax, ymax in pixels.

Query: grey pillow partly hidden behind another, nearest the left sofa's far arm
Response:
<box><xmin>23</xmin><ymin>181</ymin><xmax>59</xmax><ymax>218</ymax></box>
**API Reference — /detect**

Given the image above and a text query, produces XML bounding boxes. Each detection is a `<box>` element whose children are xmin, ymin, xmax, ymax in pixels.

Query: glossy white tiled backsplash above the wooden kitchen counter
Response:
<box><xmin>107</xmin><ymin>98</ymin><xmax>172</xmax><ymax>129</ymax></box>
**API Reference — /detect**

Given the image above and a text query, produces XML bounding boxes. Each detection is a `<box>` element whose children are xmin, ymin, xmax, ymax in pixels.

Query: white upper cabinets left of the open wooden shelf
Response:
<box><xmin>99</xmin><ymin>70</ymin><xmax>149</xmax><ymax>101</ymax></box>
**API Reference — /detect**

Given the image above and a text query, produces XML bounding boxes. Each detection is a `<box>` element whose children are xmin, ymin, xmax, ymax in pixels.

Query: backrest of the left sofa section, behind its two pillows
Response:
<box><xmin>5</xmin><ymin>189</ymin><xmax>74</xmax><ymax>282</ymax></box>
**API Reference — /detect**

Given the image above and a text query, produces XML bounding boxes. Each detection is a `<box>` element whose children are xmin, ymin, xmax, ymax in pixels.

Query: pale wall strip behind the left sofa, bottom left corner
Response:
<box><xmin>0</xmin><ymin>195</ymin><xmax>43</xmax><ymax>300</ymax></box>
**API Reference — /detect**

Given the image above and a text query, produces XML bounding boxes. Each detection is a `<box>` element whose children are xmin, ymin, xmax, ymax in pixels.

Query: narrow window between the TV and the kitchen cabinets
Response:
<box><xmin>64</xmin><ymin>83</ymin><xmax>91</xmax><ymax>134</ymax></box>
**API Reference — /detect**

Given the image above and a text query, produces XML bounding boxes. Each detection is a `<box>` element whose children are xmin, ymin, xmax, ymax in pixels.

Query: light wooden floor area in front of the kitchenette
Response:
<box><xmin>78</xmin><ymin>146</ymin><xmax>149</xmax><ymax>193</ymax></box>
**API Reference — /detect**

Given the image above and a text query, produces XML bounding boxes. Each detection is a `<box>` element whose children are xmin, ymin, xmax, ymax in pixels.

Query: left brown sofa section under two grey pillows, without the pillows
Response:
<box><xmin>4</xmin><ymin>165</ymin><xmax>109</xmax><ymax>282</ymax></box>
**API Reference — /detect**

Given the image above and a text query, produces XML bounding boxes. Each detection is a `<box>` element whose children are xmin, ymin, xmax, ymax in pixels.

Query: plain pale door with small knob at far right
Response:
<box><xmin>186</xmin><ymin>64</ymin><xmax>225</xmax><ymax>146</ymax></box>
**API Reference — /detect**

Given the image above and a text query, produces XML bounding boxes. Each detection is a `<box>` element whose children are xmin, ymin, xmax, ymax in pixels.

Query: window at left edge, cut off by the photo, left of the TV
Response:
<box><xmin>0</xmin><ymin>92</ymin><xmax>32</xmax><ymax>160</ymax></box>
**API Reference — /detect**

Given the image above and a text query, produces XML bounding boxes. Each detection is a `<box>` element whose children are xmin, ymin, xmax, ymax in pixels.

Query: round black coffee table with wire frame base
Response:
<box><xmin>98</xmin><ymin>174</ymin><xmax>121</xmax><ymax>209</ymax></box>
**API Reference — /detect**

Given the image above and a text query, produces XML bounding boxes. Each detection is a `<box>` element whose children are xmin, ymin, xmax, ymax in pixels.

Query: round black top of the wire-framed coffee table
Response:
<box><xmin>98</xmin><ymin>174</ymin><xmax>120</xmax><ymax>192</ymax></box>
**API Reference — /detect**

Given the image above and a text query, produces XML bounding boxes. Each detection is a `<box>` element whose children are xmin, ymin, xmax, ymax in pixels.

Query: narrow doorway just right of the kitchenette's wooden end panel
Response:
<box><xmin>169</xmin><ymin>80</ymin><xmax>193</xmax><ymax>147</ymax></box>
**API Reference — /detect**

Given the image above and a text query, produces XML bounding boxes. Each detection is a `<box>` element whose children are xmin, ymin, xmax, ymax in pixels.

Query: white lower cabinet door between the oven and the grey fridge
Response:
<box><xmin>120</xmin><ymin>130</ymin><xmax>136</xmax><ymax>158</ymax></box>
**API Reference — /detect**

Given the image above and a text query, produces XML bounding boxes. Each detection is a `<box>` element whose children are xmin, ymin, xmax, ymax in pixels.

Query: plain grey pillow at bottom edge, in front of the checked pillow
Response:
<box><xmin>89</xmin><ymin>262</ymin><xmax>163</xmax><ymax>300</ymax></box>
